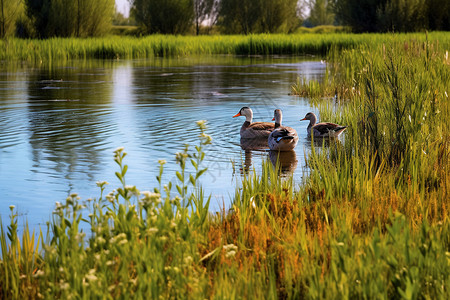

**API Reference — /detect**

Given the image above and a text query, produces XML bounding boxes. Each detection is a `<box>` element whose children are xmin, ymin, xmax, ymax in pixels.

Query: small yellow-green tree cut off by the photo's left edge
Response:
<box><xmin>0</xmin><ymin>0</ymin><xmax>23</xmax><ymax>38</ymax></box>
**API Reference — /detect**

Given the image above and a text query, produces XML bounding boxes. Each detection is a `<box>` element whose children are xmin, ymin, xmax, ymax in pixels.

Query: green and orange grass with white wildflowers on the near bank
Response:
<box><xmin>0</xmin><ymin>33</ymin><xmax>450</xmax><ymax>299</ymax></box>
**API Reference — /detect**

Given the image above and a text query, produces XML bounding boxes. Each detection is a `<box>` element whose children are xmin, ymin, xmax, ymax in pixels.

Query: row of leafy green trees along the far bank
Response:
<box><xmin>0</xmin><ymin>0</ymin><xmax>450</xmax><ymax>38</ymax></box>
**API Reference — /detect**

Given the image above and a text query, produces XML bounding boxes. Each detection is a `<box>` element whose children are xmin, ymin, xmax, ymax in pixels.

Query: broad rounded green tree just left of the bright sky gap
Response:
<box><xmin>24</xmin><ymin>0</ymin><xmax>114</xmax><ymax>38</ymax></box>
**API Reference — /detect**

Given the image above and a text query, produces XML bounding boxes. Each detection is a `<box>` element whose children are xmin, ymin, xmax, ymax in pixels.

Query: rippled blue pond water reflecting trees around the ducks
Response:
<box><xmin>0</xmin><ymin>56</ymin><xmax>325</xmax><ymax>226</ymax></box>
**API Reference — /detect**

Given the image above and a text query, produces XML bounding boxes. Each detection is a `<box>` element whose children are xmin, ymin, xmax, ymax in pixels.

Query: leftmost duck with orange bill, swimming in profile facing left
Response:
<box><xmin>233</xmin><ymin>106</ymin><xmax>275</xmax><ymax>139</ymax></box>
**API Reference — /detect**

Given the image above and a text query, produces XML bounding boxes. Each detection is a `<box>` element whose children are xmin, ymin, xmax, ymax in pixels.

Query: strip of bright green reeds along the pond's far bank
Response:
<box><xmin>0</xmin><ymin>33</ymin><xmax>448</xmax><ymax>63</ymax></box>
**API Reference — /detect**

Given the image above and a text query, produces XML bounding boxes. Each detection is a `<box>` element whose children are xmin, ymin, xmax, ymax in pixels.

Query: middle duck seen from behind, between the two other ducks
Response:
<box><xmin>267</xmin><ymin>109</ymin><xmax>298</xmax><ymax>151</ymax></box>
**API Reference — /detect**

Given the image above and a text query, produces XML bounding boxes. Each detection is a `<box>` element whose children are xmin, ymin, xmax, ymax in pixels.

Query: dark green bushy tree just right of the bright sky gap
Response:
<box><xmin>130</xmin><ymin>0</ymin><xmax>194</xmax><ymax>34</ymax></box>
